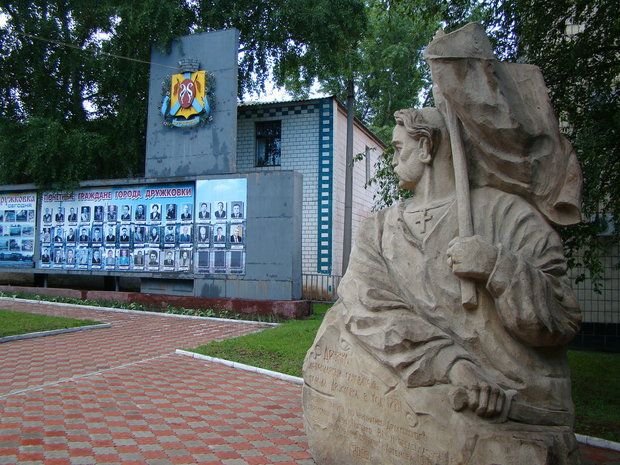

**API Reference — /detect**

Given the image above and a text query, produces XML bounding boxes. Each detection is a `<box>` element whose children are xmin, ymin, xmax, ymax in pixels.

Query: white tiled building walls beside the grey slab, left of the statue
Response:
<box><xmin>237</xmin><ymin>100</ymin><xmax>382</xmax><ymax>275</ymax></box>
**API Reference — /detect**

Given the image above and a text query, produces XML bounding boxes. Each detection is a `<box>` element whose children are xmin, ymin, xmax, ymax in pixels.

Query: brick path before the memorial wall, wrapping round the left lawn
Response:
<box><xmin>0</xmin><ymin>300</ymin><xmax>260</xmax><ymax>396</ymax></box>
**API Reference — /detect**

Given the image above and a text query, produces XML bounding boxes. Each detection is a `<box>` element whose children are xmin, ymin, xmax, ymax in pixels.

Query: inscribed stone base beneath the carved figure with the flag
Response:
<box><xmin>303</xmin><ymin>306</ymin><xmax>579</xmax><ymax>465</ymax></box>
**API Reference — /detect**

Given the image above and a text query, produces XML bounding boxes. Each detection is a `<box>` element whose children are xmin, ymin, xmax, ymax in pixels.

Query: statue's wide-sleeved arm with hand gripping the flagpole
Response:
<box><xmin>448</xmin><ymin>194</ymin><xmax>580</xmax><ymax>347</ymax></box>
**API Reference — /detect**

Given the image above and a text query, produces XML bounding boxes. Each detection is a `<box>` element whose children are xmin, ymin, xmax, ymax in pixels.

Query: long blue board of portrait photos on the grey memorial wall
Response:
<box><xmin>35</xmin><ymin>178</ymin><xmax>247</xmax><ymax>274</ymax></box>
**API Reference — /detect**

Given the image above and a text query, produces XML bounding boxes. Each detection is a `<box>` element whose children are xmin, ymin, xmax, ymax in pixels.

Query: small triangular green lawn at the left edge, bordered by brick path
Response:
<box><xmin>0</xmin><ymin>310</ymin><xmax>99</xmax><ymax>337</ymax></box>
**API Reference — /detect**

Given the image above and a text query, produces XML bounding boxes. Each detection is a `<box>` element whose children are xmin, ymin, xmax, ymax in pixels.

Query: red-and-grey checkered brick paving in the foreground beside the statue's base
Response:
<box><xmin>0</xmin><ymin>354</ymin><xmax>314</xmax><ymax>465</ymax></box>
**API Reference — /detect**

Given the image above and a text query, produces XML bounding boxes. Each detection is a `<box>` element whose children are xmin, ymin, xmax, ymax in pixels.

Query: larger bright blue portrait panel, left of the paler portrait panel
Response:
<box><xmin>38</xmin><ymin>183</ymin><xmax>196</xmax><ymax>272</ymax></box>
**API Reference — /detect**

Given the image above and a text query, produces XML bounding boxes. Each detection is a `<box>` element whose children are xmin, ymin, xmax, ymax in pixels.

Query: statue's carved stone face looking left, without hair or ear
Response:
<box><xmin>392</xmin><ymin>124</ymin><xmax>427</xmax><ymax>190</ymax></box>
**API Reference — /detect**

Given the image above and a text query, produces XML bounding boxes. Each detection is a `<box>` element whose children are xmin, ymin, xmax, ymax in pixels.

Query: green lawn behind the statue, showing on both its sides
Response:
<box><xmin>192</xmin><ymin>304</ymin><xmax>620</xmax><ymax>441</ymax></box>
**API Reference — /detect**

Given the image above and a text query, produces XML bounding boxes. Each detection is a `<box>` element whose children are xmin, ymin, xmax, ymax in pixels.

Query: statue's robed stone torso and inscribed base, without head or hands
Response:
<box><xmin>304</xmin><ymin>188</ymin><xmax>580</xmax><ymax>465</ymax></box>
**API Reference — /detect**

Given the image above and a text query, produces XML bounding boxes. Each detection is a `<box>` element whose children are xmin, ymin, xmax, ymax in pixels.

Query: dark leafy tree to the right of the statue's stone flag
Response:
<box><xmin>493</xmin><ymin>0</ymin><xmax>620</xmax><ymax>284</ymax></box>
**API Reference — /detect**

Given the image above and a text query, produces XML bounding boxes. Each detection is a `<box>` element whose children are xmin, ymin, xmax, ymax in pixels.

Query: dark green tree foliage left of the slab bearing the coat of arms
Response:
<box><xmin>0</xmin><ymin>0</ymin><xmax>190</xmax><ymax>187</ymax></box>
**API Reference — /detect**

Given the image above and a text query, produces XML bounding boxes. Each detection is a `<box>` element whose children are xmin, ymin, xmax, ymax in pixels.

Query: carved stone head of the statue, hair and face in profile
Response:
<box><xmin>392</xmin><ymin>107</ymin><xmax>449</xmax><ymax>190</ymax></box>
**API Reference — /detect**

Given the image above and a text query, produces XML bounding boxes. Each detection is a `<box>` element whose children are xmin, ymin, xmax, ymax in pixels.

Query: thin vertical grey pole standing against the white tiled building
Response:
<box><xmin>342</xmin><ymin>77</ymin><xmax>355</xmax><ymax>275</ymax></box>
